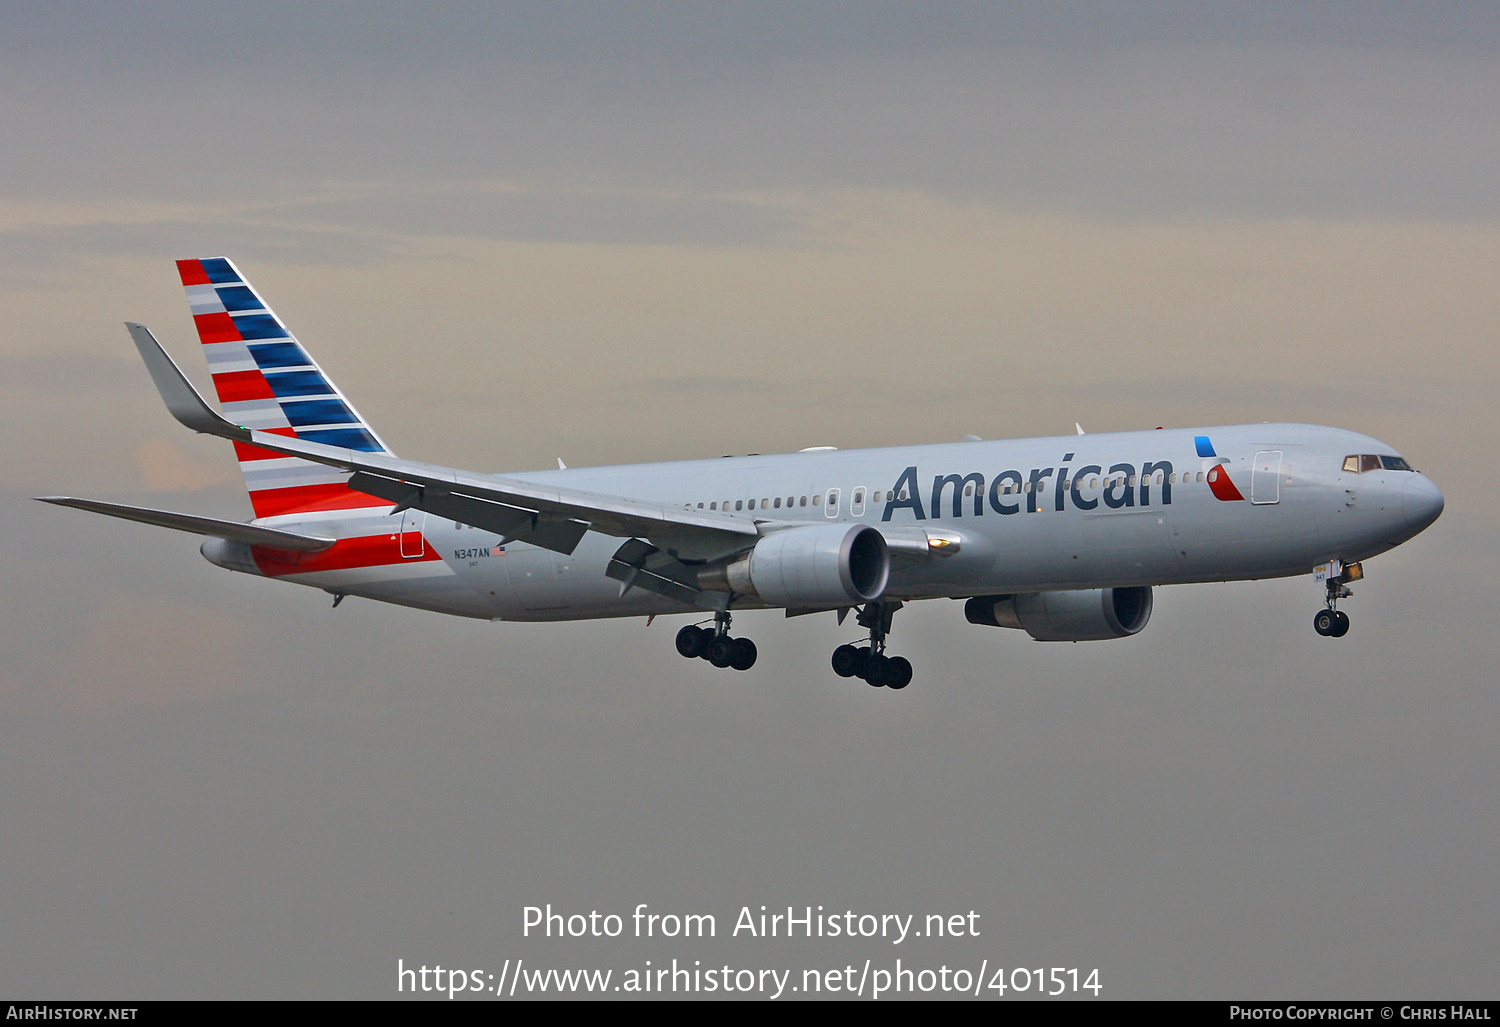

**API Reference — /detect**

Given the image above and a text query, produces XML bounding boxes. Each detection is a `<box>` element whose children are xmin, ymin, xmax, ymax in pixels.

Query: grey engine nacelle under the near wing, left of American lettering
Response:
<box><xmin>714</xmin><ymin>525</ymin><xmax>891</xmax><ymax>609</ymax></box>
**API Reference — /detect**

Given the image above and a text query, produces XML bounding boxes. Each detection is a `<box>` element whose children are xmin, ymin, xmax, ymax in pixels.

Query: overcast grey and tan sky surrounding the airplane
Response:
<box><xmin>0</xmin><ymin>3</ymin><xmax>1500</xmax><ymax>1000</ymax></box>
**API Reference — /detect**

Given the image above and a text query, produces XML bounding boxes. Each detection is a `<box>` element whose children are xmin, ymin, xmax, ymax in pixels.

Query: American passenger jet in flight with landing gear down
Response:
<box><xmin>38</xmin><ymin>256</ymin><xmax>1443</xmax><ymax>688</ymax></box>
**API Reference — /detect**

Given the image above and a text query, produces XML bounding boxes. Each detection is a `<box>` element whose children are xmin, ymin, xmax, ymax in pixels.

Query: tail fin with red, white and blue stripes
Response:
<box><xmin>177</xmin><ymin>256</ymin><xmax>390</xmax><ymax>517</ymax></box>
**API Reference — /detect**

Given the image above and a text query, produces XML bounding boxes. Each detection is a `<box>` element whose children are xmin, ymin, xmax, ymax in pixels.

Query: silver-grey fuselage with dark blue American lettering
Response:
<box><xmin>204</xmin><ymin>424</ymin><xmax>1443</xmax><ymax>621</ymax></box>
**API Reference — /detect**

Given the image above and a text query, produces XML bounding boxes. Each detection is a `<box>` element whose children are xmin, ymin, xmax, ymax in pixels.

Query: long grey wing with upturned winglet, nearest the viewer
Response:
<box><xmin>126</xmin><ymin>322</ymin><xmax>759</xmax><ymax>559</ymax></box>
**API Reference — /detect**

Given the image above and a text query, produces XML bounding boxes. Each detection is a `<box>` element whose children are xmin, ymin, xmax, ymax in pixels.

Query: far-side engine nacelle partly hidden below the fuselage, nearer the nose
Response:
<box><xmin>963</xmin><ymin>585</ymin><xmax>1152</xmax><ymax>642</ymax></box>
